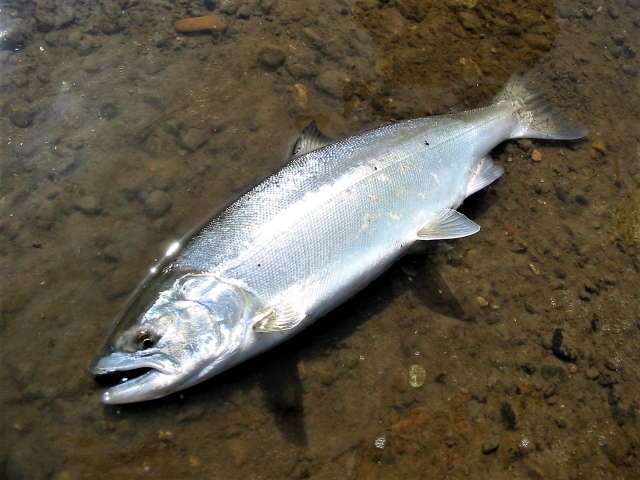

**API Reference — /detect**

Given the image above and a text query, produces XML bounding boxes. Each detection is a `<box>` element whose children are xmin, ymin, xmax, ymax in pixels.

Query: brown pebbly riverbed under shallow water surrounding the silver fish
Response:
<box><xmin>0</xmin><ymin>0</ymin><xmax>640</xmax><ymax>479</ymax></box>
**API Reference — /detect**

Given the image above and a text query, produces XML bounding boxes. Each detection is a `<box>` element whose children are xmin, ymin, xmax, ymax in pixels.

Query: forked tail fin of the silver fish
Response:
<box><xmin>495</xmin><ymin>74</ymin><xmax>589</xmax><ymax>140</ymax></box>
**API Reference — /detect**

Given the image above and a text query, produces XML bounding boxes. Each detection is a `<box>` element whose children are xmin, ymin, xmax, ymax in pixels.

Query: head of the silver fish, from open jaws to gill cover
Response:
<box><xmin>89</xmin><ymin>270</ymin><xmax>250</xmax><ymax>404</ymax></box>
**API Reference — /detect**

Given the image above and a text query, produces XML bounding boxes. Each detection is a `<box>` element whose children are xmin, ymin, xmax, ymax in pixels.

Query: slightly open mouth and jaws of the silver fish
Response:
<box><xmin>89</xmin><ymin>350</ymin><xmax>183</xmax><ymax>404</ymax></box>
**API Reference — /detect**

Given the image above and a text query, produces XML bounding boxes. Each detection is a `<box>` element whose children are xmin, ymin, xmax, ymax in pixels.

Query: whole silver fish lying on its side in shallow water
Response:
<box><xmin>89</xmin><ymin>75</ymin><xmax>587</xmax><ymax>404</ymax></box>
